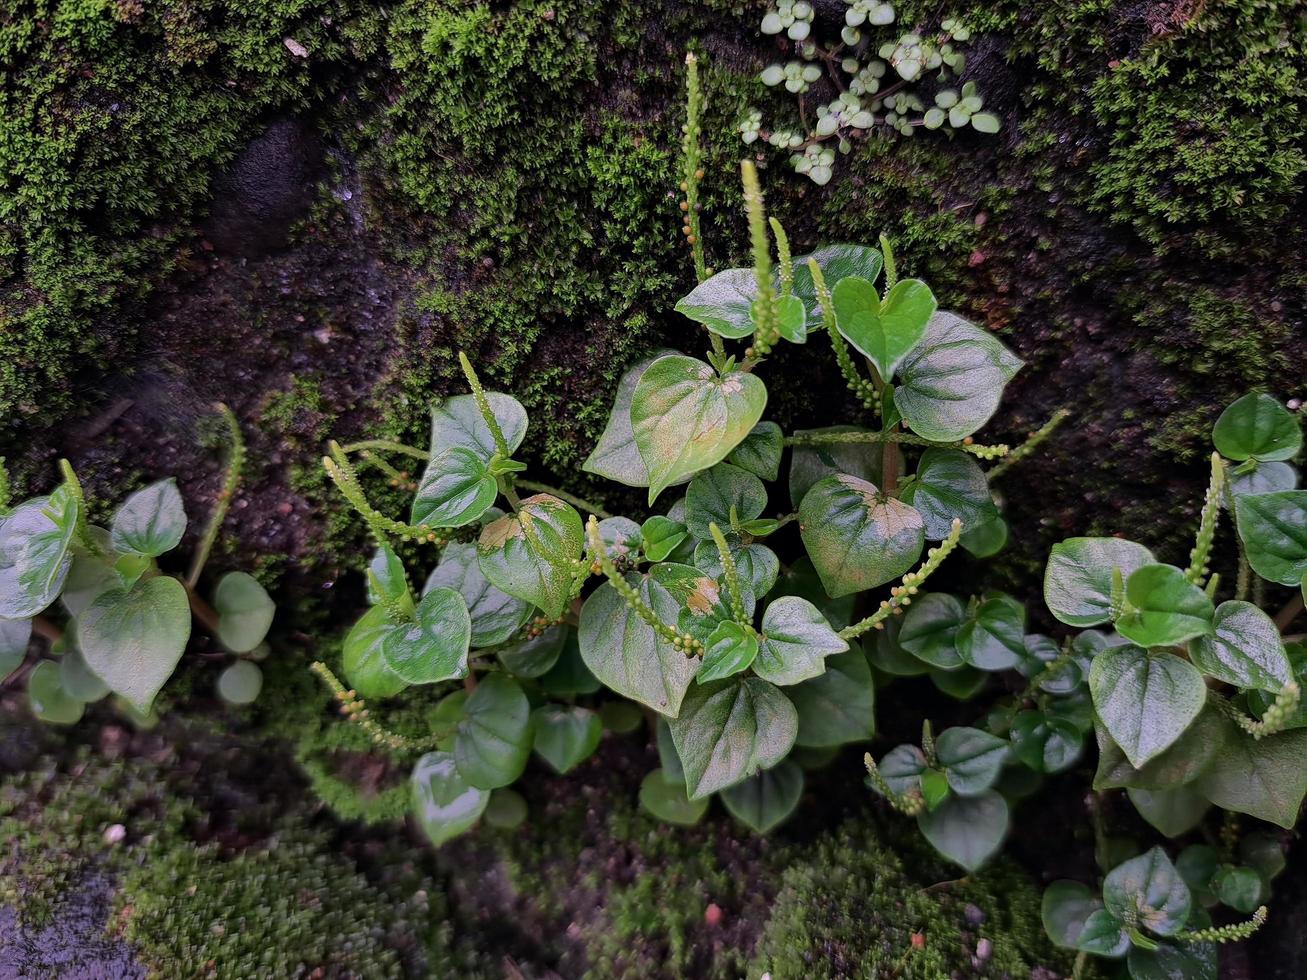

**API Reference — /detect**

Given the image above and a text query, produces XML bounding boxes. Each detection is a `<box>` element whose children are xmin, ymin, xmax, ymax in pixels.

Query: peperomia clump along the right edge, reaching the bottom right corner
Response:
<box><xmin>1029</xmin><ymin>393</ymin><xmax>1307</xmax><ymax>980</ymax></box>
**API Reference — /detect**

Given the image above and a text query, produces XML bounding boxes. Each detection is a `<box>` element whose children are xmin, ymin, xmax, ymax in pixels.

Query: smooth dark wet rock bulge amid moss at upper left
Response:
<box><xmin>204</xmin><ymin>119</ymin><xmax>323</xmax><ymax>256</ymax></box>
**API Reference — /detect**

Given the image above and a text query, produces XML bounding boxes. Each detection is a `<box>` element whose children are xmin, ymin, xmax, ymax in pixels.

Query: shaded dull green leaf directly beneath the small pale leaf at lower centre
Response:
<box><xmin>786</xmin><ymin>647</ymin><xmax>876</xmax><ymax>749</ymax></box>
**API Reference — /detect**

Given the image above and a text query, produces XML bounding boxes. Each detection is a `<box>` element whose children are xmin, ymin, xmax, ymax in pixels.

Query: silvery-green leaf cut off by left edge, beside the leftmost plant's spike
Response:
<box><xmin>0</xmin><ymin>486</ymin><xmax>80</xmax><ymax>619</ymax></box>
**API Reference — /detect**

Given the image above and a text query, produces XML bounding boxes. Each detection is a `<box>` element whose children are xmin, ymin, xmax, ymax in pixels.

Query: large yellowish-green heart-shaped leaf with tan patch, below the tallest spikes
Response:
<box><xmin>631</xmin><ymin>354</ymin><xmax>767</xmax><ymax>504</ymax></box>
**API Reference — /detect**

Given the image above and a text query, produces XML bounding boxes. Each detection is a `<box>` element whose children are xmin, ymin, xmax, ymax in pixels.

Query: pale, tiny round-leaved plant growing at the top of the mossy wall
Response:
<box><xmin>738</xmin><ymin>0</ymin><xmax>1000</xmax><ymax>184</ymax></box>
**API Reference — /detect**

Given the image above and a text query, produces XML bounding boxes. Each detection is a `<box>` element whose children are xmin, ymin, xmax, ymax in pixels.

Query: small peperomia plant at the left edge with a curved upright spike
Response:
<box><xmin>0</xmin><ymin>405</ymin><xmax>274</xmax><ymax>724</ymax></box>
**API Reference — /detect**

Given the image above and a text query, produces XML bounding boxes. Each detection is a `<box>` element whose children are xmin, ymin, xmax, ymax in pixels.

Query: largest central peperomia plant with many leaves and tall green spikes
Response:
<box><xmin>314</xmin><ymin>56</ymin><xmax>1047</xmax><ymax>844</ymax></box>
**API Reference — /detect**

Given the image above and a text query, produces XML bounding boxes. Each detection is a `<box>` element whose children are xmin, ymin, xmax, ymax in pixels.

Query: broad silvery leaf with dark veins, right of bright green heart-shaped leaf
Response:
<box><xmin>894</xmin><ymin>310</ymin><xmax>1021</xmax><ymax>442</ymax></box>
